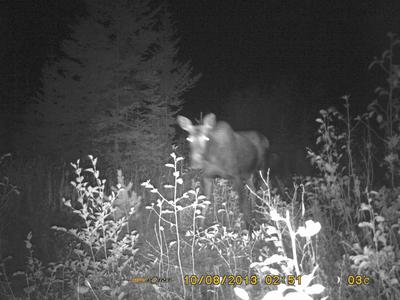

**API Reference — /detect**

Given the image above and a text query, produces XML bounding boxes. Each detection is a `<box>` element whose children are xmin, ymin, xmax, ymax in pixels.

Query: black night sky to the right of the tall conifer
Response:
<box><xmin>172</xmin><ymin>0</ymin><xmax>400</xmax><ymax>116</ymax></box>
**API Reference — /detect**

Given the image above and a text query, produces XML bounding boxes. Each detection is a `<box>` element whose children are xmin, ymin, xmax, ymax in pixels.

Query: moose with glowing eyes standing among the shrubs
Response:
<box><xmin>177</xmin><ymin>113</ymin><xmax>270</xmax><ymax>237</ymax></box>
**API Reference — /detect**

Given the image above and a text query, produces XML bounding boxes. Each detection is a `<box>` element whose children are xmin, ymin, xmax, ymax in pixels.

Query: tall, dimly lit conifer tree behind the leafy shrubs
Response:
<box><xmin>31</xmin><ymin>0</ymin><xmax>199</xmax><ymax>184</ymax></box>
